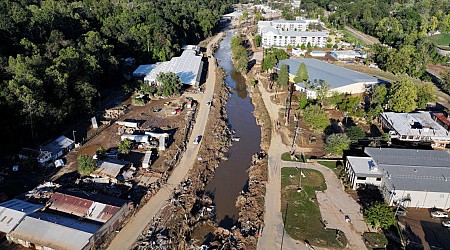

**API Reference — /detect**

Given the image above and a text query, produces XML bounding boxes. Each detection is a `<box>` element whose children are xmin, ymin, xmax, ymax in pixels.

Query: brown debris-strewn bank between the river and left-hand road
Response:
<box><xmin>135</xmin><ymin>63</ymin><xmax>236</xmax><ymax>249</ymax></box>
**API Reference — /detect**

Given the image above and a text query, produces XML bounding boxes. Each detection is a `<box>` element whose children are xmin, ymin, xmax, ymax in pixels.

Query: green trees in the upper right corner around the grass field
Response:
<box><xmin>319</xmin><ymin>0</ymin><xmax>450</xmax><ymax>79</ymax></box>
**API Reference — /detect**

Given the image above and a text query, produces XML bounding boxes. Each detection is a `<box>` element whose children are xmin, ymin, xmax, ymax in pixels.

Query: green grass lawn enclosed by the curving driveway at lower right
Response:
<box><xmin>281</xmin><ymin>168</ymin><xmax>347</xmax><ymax>248</ymax></box>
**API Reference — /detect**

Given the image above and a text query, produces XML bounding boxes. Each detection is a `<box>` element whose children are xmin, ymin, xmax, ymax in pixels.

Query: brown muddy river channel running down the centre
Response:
<box><xmin>206</xmin><ymin>30</ymin><xmax>261</xmax><ymax>228</ymax></box>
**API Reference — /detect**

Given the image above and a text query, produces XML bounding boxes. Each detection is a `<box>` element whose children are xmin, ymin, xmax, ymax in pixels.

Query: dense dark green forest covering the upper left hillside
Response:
<box><xmin>0</xmin><ymin>0</ymin><xmax>232</xmax><ymax>155</ymax></box>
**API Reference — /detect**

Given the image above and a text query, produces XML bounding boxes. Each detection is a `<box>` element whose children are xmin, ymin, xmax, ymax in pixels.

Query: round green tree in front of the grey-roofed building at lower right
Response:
<box><xmin>364</xmin><ymin>203</ymin><xmax>395</xmax><ymax>230</ymax></box>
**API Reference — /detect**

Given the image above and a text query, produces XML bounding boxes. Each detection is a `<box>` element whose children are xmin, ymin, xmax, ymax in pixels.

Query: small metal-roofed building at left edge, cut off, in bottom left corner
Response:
<box><xmin>0</xmin><ymin>199</ymin><xmax>43</xmax><ymax>233</ymax></box>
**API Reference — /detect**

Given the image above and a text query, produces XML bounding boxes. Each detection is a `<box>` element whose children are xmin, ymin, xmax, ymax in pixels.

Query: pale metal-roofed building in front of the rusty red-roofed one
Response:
<box><xmin>8</xmin><ymin>212</ymin><xmax>100</xmax><ymax>250</ymax></box>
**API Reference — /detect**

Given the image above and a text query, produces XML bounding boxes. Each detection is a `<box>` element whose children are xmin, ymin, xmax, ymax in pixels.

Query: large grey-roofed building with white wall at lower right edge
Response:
<box><xmin>365</xmin><ymin>148</ymin><xmax>450</xmax><ymax>208</ymax></box>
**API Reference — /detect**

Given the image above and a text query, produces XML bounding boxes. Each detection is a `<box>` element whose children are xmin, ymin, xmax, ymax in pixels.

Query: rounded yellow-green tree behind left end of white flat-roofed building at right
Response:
<box><xmin>389</xmin><ymin>76</ymin><xmax>417</xmax><ymax>113</ymax></box>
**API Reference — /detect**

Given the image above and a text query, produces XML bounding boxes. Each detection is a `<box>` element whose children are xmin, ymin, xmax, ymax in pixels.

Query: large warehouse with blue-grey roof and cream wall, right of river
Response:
<box><xmin>277</xmin><ymin>58</ymin><xmax>382</xmax><ymax>99</ymax></box>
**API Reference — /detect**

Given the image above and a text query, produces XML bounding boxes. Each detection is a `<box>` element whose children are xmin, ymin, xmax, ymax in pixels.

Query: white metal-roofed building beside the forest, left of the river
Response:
<box><xmin>144</xmin><ymin>49</ymin><xmax>203</xmax><ymax>85</ymax></box>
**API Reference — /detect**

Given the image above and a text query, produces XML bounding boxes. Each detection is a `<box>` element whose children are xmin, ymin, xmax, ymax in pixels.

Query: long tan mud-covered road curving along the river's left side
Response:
<box><xmin>108</xmin><ymin>33</ymin><xmax>222</xmax><ymax>250</ymax></box>
